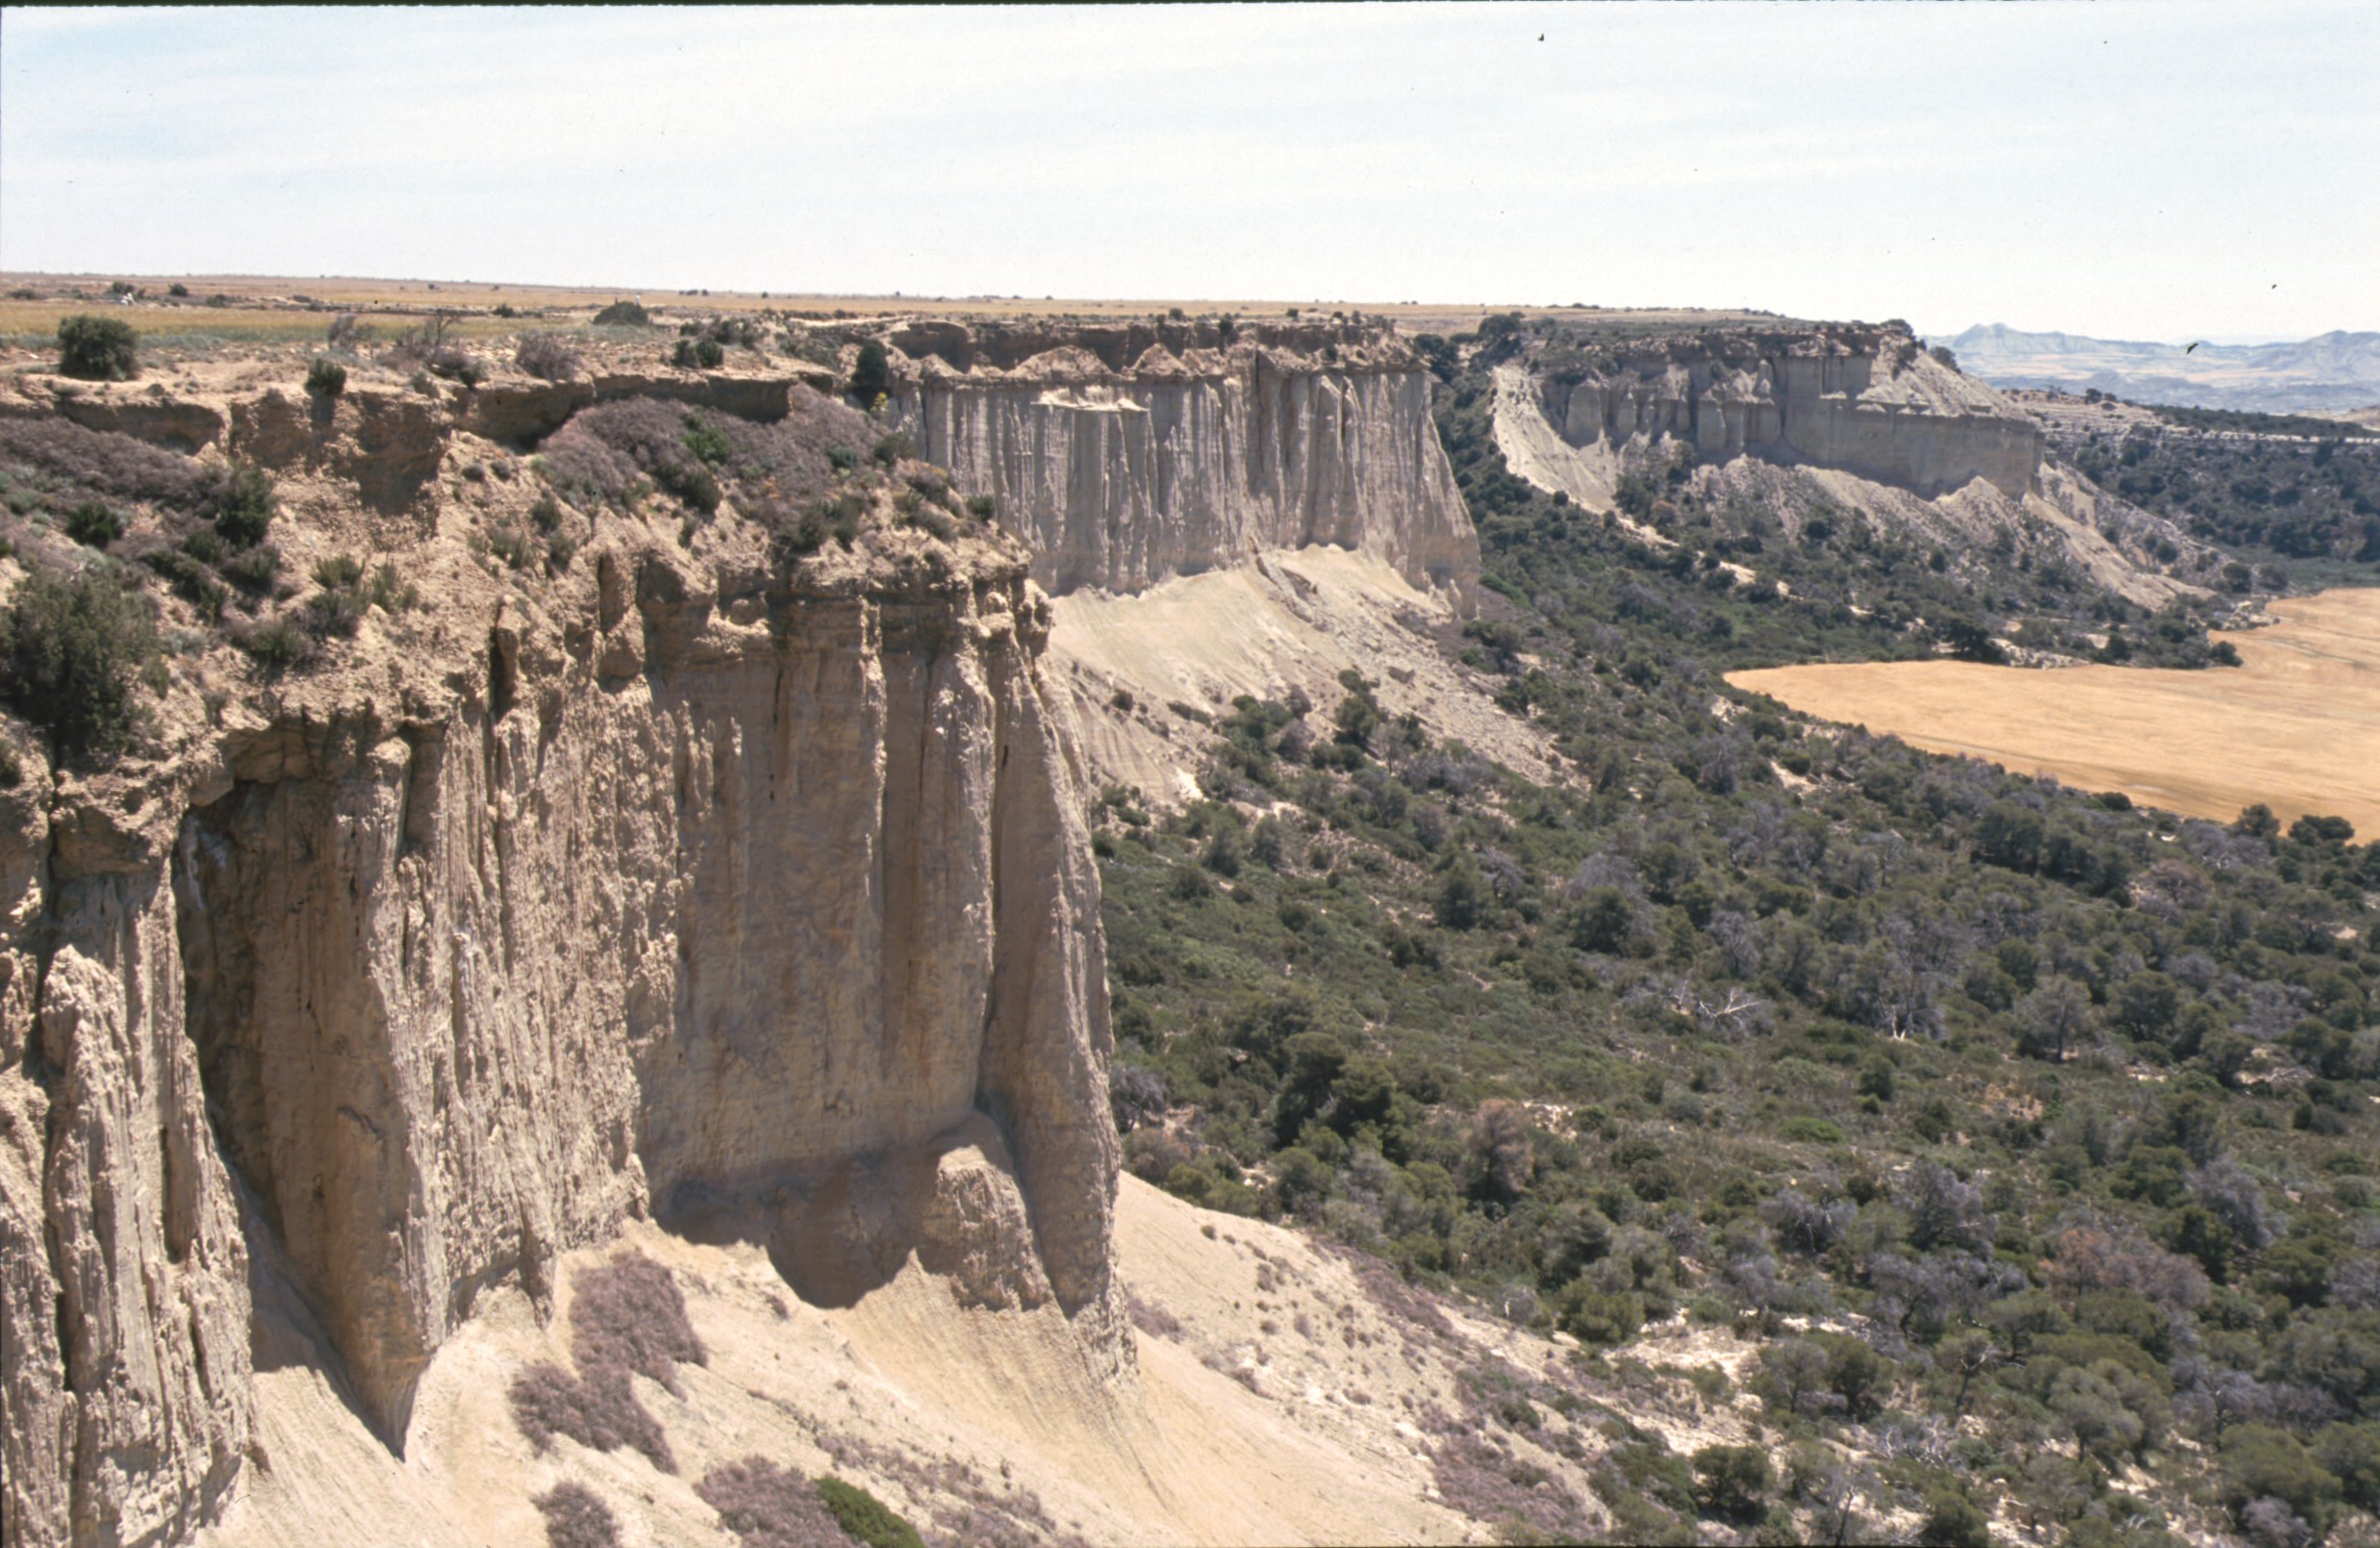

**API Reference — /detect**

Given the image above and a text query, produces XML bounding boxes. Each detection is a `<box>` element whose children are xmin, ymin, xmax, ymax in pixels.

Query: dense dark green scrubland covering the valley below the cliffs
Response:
<box><xmin>1095</xmin><ymin>318</ymin><xmax>2380</xmax><ymax>1543</ymax></box>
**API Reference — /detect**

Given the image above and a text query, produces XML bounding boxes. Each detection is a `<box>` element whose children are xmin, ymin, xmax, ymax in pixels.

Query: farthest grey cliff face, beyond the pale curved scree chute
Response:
<box><xmin>1545</xmin><ymin>326</ymin><xmax>2042</xmax><ymax>495</ymax></box>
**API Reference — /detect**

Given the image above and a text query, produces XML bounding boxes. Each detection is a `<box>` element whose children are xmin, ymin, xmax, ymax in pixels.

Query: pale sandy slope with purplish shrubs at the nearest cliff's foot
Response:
<box><xmin>200</xmin><ymin>1179</ymin><xmax>1752</xmax><ymax>1548</ymax></box>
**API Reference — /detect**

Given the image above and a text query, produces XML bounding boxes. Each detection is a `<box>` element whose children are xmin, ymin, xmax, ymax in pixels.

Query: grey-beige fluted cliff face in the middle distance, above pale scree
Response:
<box><xmin>893</xmin><ymin>324</ymin><xmax>1478</xmax><ymax>607</ymax></box>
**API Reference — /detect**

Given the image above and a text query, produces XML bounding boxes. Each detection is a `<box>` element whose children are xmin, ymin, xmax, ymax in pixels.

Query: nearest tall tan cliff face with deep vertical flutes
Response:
<box><xmin>0</xmin><ymin>394</ymin><xmax>1128</xmax><ymax>1543</ymax></box>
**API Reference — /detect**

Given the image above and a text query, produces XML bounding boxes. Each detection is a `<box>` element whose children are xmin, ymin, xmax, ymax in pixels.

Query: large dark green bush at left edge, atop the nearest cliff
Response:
<box><xmin>0</xmin><ymin>565</ymin><xmax>157</xmax><ymax>767</ymax></box>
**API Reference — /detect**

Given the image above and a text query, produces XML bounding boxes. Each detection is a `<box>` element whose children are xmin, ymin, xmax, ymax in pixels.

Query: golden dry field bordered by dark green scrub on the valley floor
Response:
<box><xmin>1728</xmin><ymin>591</ymin><xmax>2380</xmax><ymax>838</ymax></box>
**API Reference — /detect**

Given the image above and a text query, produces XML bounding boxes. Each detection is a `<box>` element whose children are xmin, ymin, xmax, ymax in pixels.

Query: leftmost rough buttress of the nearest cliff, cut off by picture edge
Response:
<box><xmin>0</xmin><ymin>770</ymin><xmax>250</xmax><ymax>1543</ymax></box>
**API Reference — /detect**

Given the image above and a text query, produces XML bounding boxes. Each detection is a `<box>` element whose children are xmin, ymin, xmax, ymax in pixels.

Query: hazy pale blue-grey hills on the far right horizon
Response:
<box><xmin>1928</xmin><ymin>324</ymin><xmax>2380</xmax><ymax>415</ymax></box>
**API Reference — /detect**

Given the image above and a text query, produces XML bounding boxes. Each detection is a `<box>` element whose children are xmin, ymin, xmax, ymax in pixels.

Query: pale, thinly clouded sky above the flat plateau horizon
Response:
<box><xmin>0</xmin><ymin>0</ymin><xmax>2380</xmax><ymax>341</ymax></box>
